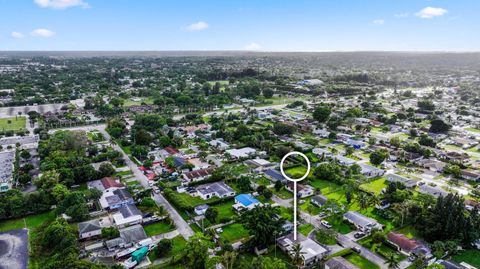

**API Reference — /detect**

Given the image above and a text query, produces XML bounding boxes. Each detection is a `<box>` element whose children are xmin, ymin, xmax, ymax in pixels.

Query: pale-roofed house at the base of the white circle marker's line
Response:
<box><xmin>277</xmin><ymin>233</ymin><xmax>328</xmax><ymax>268</ymax></box>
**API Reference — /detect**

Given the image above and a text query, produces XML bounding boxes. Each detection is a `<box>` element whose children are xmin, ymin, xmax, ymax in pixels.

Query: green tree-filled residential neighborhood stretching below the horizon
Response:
<box><xmin>0</xmin><ymin>53</ymin><xmax>480</xmax><ymax>269</ymax></box>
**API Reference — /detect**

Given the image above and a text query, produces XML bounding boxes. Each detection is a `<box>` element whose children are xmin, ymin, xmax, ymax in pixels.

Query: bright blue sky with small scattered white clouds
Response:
<box><xmin>0</xmin><ymin>0</ymin><xmax>480</xmax><ymax>51</ymax></box>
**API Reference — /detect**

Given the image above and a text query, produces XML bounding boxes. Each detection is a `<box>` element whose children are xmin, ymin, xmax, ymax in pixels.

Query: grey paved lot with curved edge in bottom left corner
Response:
<box><xmin>0</xmin><ymin>229</ymin><xmax>28</xmax><ymax>269</ymax></box>
